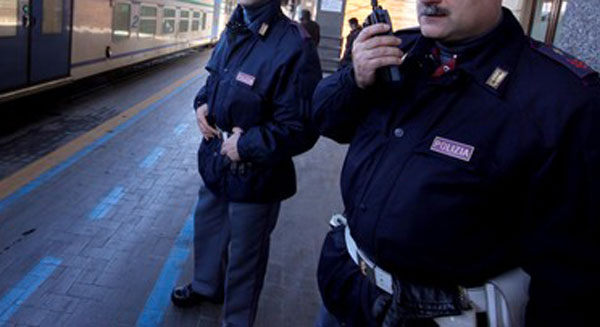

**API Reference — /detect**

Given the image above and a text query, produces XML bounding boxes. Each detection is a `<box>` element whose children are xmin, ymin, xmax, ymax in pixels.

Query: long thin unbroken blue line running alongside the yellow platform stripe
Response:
<box><xmin>0</xmin><ymin>74</ymin><xmax>205</xmax><ymax>212</ymax></box>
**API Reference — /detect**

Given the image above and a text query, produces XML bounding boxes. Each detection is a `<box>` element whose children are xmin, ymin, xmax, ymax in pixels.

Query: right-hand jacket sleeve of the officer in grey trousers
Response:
<box><xmin>238</xmin><ymin>39</ymin><xmax>322</xmax><ymax>164</ymax></box>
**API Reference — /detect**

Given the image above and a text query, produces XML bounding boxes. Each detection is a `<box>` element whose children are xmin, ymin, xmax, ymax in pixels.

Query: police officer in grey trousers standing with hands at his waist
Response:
<box><xmin>171</xmin><ymin>0</ymin><xmax>321</xmax><ymax>326</ymax></box>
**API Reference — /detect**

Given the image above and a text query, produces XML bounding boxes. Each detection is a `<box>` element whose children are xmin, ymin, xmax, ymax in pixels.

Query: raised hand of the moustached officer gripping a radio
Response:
<box><xmin>352</xmin><ymin>24</ymin><xmax>404</xmax><ymax>89</ymax></box>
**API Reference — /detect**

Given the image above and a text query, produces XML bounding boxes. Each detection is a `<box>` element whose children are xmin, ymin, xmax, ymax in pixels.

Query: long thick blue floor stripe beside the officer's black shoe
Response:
<box><xmin>136</xmin><ymin>215</ymin><xmax>194</xmax><ymax>327</ymax></box>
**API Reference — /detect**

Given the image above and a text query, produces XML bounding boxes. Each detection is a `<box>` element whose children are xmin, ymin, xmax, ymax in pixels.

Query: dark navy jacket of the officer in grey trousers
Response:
<box><xmin>194</xmin><ymin>0</ymin><xmax>321</xmax><ymax>202</ymax></box>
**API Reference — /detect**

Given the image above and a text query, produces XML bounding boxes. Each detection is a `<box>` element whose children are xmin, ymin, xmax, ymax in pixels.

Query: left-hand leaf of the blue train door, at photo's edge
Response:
<box><xmin>0</xmin><ymin>0</ymin><xmax>30</xmax><ymax>90</ymax></box>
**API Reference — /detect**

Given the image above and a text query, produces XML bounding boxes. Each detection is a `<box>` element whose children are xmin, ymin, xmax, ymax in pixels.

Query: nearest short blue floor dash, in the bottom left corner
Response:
<box><xmin>0</xmin><ymin>257</ymin><xmax>62</xmax><ymax>326</ymax></box>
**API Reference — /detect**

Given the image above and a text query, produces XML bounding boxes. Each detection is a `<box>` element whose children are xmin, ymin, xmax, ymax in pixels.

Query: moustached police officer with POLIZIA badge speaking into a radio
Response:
<box><xmin>313</xmin><ymin>0</ymin><xmax>600</xmax><ymax>327</ymax></box>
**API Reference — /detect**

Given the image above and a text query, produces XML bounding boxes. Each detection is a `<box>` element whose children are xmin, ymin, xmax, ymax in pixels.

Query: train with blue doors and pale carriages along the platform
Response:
<box><xmin>0</xmin><ymin>0</ymin><xmax>236</xmax><ymax>101</ymax></box>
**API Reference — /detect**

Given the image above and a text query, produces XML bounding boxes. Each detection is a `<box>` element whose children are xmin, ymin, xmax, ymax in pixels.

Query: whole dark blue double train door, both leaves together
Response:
<box><xmin>0</xmin><ymin>0</ymin><xmax>72</xmax><ymax>91</ymax></box>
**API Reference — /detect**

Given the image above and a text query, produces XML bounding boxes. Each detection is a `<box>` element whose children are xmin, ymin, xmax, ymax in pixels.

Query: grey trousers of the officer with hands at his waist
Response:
<box><xmin>192</xmin><ymin>185</ymin><xmax>280</xmax><ymax>327</ymax></box>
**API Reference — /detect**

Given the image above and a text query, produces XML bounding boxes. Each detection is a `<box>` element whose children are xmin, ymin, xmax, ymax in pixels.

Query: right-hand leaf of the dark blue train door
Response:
<box><xmin>30</xmin><ymin>0</ymin><xmax>71</xmax><ymax>83</ymax></box>
